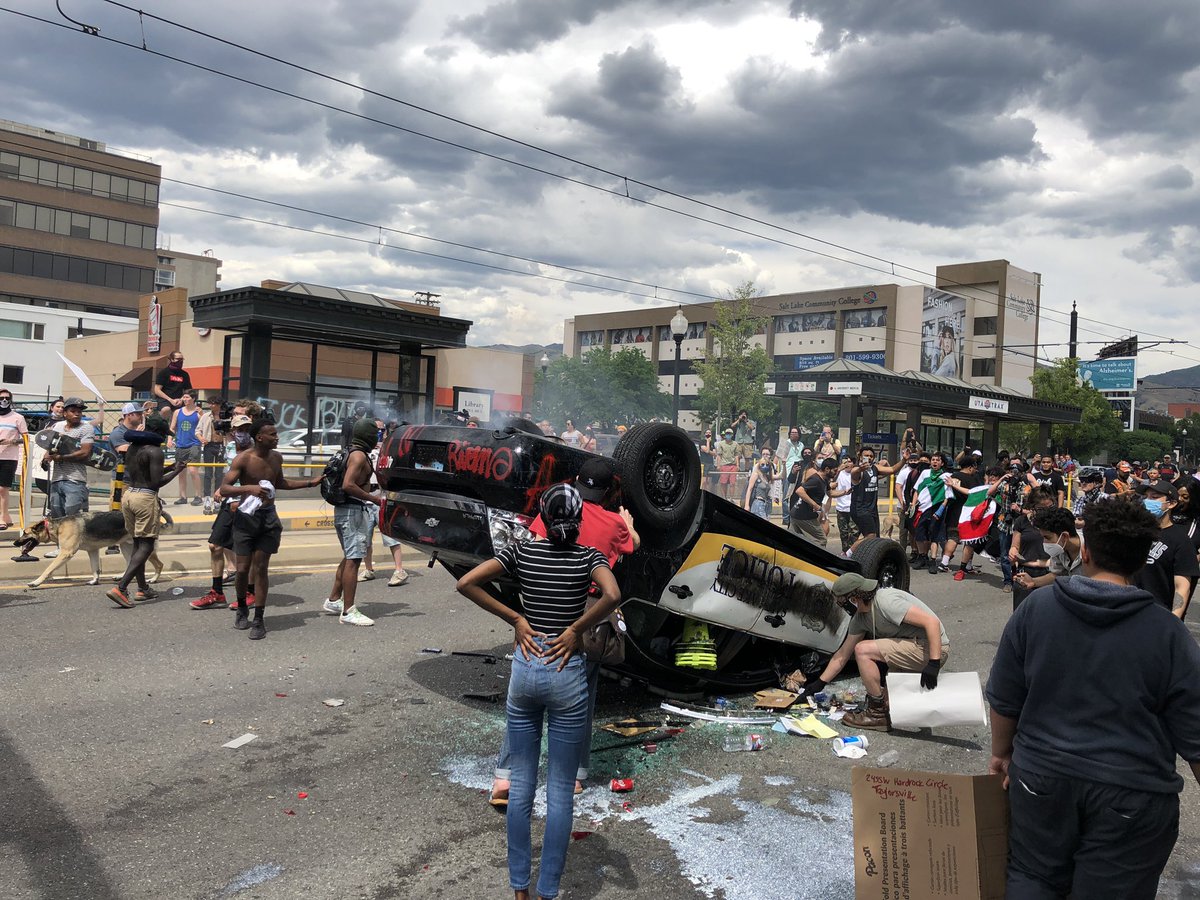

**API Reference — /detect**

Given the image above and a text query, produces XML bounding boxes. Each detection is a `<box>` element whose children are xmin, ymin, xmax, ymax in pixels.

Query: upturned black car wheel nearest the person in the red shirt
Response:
<box><xmin>613</xmin><ymin>422</ymin><xmax>700</xmax><ymax>550</ymax></box>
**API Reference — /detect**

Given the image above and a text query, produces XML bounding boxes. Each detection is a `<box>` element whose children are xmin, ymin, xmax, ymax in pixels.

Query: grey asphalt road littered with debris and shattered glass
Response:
<box><xmin>0</xmin><ymin>535</ymin><xmax>1200</xmax><ymax>900</ymax></box>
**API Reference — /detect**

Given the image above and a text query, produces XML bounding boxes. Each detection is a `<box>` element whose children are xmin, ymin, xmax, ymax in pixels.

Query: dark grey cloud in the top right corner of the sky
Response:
<box><xmin>791</xmin><ymin>0</ymin><xmax>1200</xmax><ymax>137</ymax></box>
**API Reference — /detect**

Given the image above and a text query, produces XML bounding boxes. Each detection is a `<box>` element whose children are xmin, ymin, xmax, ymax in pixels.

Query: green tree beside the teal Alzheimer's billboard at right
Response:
<box><xmin>1000</xmin><ymin>359</ymin><xmax>1123</xmax><ymax>461</ymax></box>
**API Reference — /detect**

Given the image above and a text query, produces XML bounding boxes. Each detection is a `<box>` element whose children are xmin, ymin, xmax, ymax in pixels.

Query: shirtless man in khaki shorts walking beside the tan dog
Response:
<box><xmin>104</xmin><ymin>414</ymin><xmax>187</xmax><ymax>610</ymax></box>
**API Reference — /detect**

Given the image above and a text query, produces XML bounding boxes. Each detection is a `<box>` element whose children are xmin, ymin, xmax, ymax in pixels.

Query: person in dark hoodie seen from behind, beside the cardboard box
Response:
<box><xmin>986</xmin><ymin>498</ymin><xmax>1200</xmax><ymax>900</ymax></box>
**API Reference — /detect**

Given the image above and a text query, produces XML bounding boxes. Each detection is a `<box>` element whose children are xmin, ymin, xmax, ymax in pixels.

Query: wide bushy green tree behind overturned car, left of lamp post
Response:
<box><xmin>534</xmin><ymin>347</ymin><xmax>671</xmax><ymax>431</ymax></box>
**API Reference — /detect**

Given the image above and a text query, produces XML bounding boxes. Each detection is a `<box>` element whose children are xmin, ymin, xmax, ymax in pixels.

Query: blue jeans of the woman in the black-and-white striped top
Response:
<box><xmin>506</xmin><ymin>650</ymin><xmax>589</xmax><ymax>899</ymax></box>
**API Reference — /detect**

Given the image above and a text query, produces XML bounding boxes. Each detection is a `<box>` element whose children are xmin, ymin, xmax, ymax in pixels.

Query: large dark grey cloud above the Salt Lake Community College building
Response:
<box><xmin>548</xmin><ymin>30</ymin><xmax>1044</xmax><ymax>223</ymax></box>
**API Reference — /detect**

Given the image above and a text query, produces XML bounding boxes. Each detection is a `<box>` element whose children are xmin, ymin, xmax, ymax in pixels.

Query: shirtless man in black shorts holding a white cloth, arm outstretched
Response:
<box><xmin>221</xmin><ymin>420</ymin><xmax>320</xmax><ymax>641</ymax></box>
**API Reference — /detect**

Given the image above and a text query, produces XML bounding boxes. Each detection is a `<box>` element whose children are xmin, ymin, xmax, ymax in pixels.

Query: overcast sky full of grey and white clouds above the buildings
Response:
<box><xmin>0</xmin><ymin>0</ymin><xmax>1200</xmax><ymax>374</ymax></box>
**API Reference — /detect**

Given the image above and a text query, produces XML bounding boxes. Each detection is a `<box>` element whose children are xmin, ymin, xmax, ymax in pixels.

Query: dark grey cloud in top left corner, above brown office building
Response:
<box><xmin>0</xmin><ymin>0</ymin><xmax>415</xmax><ymax>157</ymax></box>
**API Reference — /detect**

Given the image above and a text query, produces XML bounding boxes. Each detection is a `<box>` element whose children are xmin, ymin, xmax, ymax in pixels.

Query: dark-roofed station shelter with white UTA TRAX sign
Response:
<box><xmin>767</xmin><ymin>359</ymin><xmax>1082</xmax><ymax>460</ymax></box>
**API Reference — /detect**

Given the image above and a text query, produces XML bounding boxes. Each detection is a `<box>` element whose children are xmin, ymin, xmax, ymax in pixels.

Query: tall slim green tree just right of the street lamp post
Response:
<box><xmin>695</xmin><ymin>281</ymin><xmax>776</xmax><ymax>438</ymax></box>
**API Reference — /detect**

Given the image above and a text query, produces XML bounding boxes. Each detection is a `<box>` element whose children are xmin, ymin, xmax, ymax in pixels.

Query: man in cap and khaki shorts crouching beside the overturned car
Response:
<box><xmin>804</xmin><ymin>572</ymin><xmax>950</xmax><ymax>731</ymax></box>
